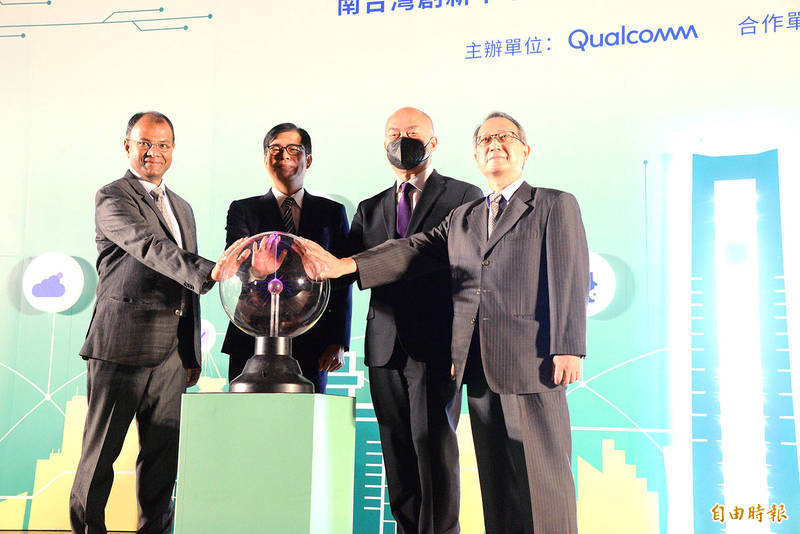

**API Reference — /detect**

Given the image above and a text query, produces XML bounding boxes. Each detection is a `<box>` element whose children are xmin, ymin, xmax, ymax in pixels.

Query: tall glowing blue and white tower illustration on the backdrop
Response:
<box><xmin>691</xmin><ymin>150</ymin><xmax>800</xmax><ymax>533</ymax></box>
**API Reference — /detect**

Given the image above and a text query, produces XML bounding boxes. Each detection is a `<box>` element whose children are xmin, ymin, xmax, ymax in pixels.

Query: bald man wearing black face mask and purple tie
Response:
<box><xmin>348</xmin><ymin>108</ymin><xmax>483</xmax><ymax>534</ymax></box>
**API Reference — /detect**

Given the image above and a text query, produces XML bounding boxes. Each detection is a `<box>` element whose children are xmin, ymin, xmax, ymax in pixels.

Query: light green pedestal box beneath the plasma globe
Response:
<box><xmin>174</xmin><ymin>393</ymin><xmax>355</xmax><ymax>534</ymax></box>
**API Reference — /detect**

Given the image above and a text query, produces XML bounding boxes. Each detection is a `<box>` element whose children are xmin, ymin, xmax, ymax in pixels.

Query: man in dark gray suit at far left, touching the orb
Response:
<box><xmin>70</xmin><ymin>112</ymin><xmax>249</xmax><ymax>534</ymax></box>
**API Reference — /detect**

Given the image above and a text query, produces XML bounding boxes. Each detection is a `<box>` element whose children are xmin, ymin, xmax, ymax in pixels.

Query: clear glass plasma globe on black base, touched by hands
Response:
<box><xmin>219</xmin><ymin>232</ymin><xmax>330</xmax><ymax>337</ymax></box>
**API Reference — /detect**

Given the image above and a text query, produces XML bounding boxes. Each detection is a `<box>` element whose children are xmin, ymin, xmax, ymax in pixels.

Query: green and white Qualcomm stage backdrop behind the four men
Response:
<box><xmin>0</xmin><ymin>0</ymin><xmax>800</xmax><ymax>534</ymax></box>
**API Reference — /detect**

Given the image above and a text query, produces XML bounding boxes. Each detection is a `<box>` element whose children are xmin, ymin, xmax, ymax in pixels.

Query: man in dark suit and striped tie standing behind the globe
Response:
<box><xmin>222</xmin><ymin>123</ymin><xmax>352</xmax><ymax>393</ymax></box>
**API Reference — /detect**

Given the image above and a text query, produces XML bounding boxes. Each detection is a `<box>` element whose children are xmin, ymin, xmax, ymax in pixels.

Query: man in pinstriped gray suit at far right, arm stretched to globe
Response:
<box><xmin>304</xmin><ymin>113</ymin><xmax>589</xmax><ymax>534</ymax></box>
